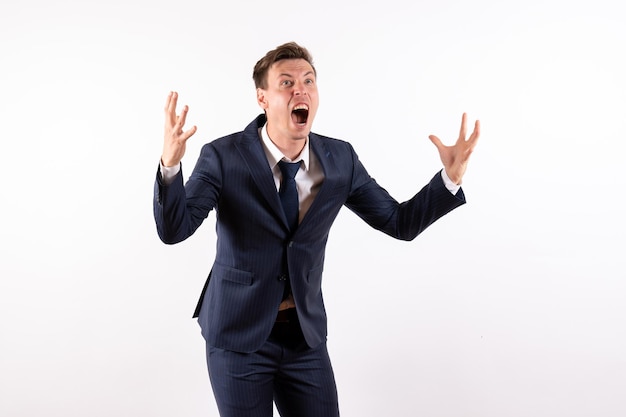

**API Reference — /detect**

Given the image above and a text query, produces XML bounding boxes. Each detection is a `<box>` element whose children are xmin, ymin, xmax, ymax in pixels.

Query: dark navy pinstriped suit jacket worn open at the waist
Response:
<box><xmin>154</xmin><ymin>115</ymin><xmax>465</xmax><ymax>352</ymax></box>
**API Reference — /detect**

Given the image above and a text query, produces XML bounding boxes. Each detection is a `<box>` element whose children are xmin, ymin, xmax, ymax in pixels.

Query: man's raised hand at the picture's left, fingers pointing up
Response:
<box><xmin>161</xmin><ymin>91</ymin><xmax>197</xmax><ymax>167</ymax></box>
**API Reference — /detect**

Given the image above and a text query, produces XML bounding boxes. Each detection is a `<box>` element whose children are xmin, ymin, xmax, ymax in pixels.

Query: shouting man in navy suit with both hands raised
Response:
<box><xmin>154</xmin><ymin>43</ymin><xmax>479</xmax><ymax>417</ymax></box>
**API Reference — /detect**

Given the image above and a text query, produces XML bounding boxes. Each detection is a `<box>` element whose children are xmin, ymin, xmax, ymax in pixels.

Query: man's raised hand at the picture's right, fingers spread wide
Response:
<box><xmin>428</xmin><ymin>113</ymin><xmax>480</xmax><ymax>185</ymax></box>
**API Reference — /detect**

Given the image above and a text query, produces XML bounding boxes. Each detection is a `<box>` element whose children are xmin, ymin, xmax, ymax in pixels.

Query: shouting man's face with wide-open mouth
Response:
<box><xmin>257</xmin><ymin>59</ymin><xmax>319</xmax><ymax>145</ymax></box>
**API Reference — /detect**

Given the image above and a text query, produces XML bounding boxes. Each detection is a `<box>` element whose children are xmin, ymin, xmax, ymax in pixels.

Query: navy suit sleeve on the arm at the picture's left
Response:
<box><xmin>153</xmin><ymin>144</ymin><xmax>221</xmax><ymax>244</ymax></box>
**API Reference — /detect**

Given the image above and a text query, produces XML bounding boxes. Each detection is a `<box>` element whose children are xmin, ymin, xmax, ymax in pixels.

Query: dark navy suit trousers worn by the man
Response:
<box><xmin>207</xmin><ymin>309</ymin><xmax>339</xmax><ymax>417</ymax></box>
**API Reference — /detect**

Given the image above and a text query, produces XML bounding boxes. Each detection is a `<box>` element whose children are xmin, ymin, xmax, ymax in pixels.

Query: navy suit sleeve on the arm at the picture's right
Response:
<box><xmin>346</xmin><ymin>144</ymin><xmax>465</xmax><ymax>240</ymax></box>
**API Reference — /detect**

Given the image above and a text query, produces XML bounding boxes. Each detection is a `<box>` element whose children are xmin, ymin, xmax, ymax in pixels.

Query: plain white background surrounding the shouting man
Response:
<box><xmin>0</xmin><ymin>0</ymin><xmax>626</xmax><ymax>417</ymax></box>
